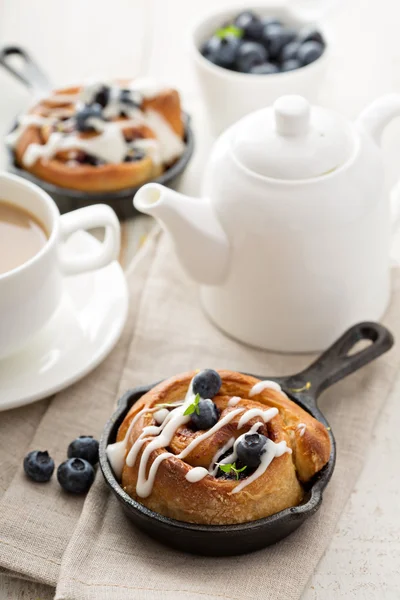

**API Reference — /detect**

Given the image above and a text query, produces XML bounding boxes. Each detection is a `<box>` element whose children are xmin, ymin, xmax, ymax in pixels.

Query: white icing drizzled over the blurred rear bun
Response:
<box><xmin>6</xmin><ymin>79</ymin><xmax>185</xmax><ymax>167</ymax></box>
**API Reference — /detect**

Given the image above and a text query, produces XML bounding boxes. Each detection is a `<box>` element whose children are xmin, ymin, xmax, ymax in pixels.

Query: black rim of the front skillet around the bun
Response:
<box><xmin>99</xmin><ymin>376</ymin><xmax>336</xmax><ymax>534</ymax></box>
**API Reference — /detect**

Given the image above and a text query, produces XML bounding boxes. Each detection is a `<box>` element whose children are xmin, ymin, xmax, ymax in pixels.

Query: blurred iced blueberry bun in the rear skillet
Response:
<box><xmin>6</xmin><ymin>79</ymin><xmax>185</xmax><ymax>192</ymax></box>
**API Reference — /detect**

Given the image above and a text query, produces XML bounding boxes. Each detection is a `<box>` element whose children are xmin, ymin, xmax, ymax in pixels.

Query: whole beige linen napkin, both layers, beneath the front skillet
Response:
<box><xmin>0</xmin><ymin>230</ymin><xmax>400</xmax><ymax>600</ymax></box>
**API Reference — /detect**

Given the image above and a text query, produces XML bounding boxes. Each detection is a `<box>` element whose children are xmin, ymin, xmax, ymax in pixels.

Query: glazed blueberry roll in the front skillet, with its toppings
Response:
<box><xmin>107</xmin><ymin>369</ymin><xmax>330</xmax><ymax>525</ymax></box>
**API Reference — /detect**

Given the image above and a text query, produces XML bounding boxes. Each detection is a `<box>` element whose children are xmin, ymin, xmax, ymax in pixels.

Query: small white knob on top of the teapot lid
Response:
<box><xmin>274</xmin><ymin>95</ymin><xmax>310</xmax><ymax>136</ymax></box>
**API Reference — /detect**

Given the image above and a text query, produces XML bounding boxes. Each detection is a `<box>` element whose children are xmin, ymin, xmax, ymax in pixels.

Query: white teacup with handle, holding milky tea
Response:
<box><xmin>0</xmin><ymin>173</ymin><xmax>120</xmax><ymax>358</ymax></box>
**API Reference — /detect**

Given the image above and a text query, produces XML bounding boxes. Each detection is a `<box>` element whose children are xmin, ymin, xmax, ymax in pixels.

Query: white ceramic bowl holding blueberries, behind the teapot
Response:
<box><xmin>191</xmin><ymin>4</ymin><xmax>329</xmax><ymax>134</ymax></box>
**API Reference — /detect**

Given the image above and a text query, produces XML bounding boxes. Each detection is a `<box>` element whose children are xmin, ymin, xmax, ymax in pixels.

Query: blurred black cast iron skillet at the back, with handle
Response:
<box><xmin>0</xmin><ymin>46</ymin><xmax>194</xmax><ymax>219</ymax></box>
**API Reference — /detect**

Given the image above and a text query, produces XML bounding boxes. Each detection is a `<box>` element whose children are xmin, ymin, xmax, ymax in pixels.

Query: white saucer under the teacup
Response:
<box><xmin>0</xmin><ymin>231</ymin><xmax>128</xmax><ymax>410</ymax></box>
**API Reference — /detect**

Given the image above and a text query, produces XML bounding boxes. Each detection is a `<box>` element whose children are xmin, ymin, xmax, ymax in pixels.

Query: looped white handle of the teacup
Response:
<box><xmin>59</xmin><ymin>204</ymin><xmax>121</xmax><ymax>275</ymax></box>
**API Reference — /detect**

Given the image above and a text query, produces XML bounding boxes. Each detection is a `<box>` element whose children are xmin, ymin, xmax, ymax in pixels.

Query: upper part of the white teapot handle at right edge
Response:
<box><xmin>357</xmin><ymin>94</ymin><xmax>400</xmax><ymax>145</ymax></box>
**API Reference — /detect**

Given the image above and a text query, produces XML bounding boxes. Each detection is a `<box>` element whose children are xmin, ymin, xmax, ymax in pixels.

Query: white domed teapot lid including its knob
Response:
<box><xmin>231</xmin><ymin>95</ymin><xmax>354</xmax><ymax>180</ymax></box>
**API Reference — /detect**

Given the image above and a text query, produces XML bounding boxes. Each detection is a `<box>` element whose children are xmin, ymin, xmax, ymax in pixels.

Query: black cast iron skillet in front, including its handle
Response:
<box><xmin>99</xmin><ymin>323</ymin><xmax>394</xmax><ymax>556</ymax></box>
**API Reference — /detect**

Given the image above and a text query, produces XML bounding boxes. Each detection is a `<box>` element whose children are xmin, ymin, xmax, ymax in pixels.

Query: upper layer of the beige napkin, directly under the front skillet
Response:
<box><xmin>50</xmin><ymin>236</ymin><xmax>400</xmax><ymax>600</ymax></box>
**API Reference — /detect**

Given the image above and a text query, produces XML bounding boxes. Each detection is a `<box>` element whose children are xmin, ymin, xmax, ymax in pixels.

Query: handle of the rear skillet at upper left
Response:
<box><xmin>0</xmin><ymin>46</ymin><xmax>53</xmax><ymax>92</ymax></box>
